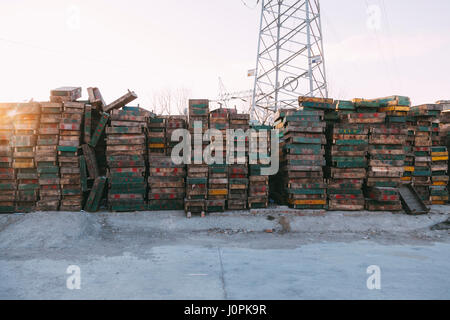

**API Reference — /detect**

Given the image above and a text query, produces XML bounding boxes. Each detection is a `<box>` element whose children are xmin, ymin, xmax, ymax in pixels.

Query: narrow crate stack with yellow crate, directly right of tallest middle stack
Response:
<box><xmin>206</xmin><ymin>108</ymin><xmax>230</xmax><ymax>212</ymax></box>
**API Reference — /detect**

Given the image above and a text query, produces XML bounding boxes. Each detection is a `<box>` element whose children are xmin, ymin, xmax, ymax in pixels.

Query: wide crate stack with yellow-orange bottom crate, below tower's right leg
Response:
<box><xmin>279</xmin><ymin>107</ymin><xmax>327</xmax><ymax>209</ymax></box>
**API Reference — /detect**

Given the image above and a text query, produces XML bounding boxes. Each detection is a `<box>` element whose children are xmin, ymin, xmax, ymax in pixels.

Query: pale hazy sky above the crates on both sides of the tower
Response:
<box><xmin>0</xmin><ymin>0</ymin><xmax>450</xmax><ymax>109</ymax></box>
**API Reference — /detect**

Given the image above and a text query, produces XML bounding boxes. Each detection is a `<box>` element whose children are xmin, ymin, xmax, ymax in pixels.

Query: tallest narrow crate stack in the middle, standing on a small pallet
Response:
<box><xmin>184</xmin><ymin>100</ymin><xmax>209</xmax><ymax>217</ymax></box>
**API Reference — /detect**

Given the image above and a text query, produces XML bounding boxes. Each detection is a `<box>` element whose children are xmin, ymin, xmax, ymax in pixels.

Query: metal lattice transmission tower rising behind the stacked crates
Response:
<box><xmin>252</xmin><ymin>0</ymin><xmax>328</xmax><ymax>114</ymax></box>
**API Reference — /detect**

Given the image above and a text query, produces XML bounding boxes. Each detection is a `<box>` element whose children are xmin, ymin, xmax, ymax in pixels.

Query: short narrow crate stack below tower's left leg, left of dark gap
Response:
<box><xmin>248</xmin><ymin>125</ymin><xmax>272</xmax><ymax>209</ymax></box>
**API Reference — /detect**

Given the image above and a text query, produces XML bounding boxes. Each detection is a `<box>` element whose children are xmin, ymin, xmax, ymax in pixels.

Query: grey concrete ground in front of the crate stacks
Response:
<box><xmin>0</xmin><ymin>206</ymin><xmax>450</xmax><ymax>299</ymax></box>
